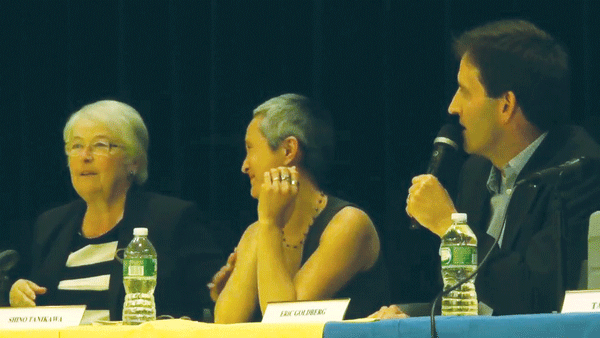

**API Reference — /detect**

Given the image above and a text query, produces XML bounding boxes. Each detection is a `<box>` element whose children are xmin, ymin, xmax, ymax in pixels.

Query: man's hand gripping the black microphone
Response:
<box><xmin>406</xmin><ymin>174</ymin><xmax>456</xmax><ymax>237</ymax></box>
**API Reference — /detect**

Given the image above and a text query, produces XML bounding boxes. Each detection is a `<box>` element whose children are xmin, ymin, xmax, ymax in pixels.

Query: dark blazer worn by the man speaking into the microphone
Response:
<box><xmin>456</xmin><ymin>126</ymin><xmax>600</xmax><ymax>315</ymax></box>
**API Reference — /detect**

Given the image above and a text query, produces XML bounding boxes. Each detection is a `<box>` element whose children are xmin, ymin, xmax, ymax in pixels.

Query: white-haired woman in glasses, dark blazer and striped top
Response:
<box><xmin>10</xmin><ymin>100</ymin><xmax>220</xmax><ymax>320</ymax></box>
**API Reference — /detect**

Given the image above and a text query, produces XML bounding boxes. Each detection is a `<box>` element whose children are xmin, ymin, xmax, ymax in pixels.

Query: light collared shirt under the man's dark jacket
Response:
<box><xmin>487</xmin><ymin>132</ymin><xmax>548</xmax><ymax>247</ymax></box>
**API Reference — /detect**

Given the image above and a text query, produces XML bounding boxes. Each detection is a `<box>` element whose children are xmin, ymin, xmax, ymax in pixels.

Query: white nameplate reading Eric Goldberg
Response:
<box><xmin>262</xmin><ymin>298</ymin><xmax>350</xmax><ymax>323</ymax></box>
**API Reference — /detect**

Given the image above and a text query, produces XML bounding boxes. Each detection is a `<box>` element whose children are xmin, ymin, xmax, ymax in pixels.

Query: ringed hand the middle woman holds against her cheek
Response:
<box><xmin>258</xmin><ymin>167</ymin><xmax>299</xmax><ymax>227</ymax></box>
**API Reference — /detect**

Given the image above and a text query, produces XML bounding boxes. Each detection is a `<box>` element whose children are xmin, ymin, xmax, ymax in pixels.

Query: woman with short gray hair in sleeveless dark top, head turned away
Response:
<box><xmin>209</xmin><ymin>94</ymin><xmax>389</xmax><ymax>323</ymax></box>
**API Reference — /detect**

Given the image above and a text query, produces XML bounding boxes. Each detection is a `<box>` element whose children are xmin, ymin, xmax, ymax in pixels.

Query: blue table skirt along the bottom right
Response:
<box><xmin>323</xmin><ymin>313</ymin><xmax>600</xmax><ymax>338</ymax></box>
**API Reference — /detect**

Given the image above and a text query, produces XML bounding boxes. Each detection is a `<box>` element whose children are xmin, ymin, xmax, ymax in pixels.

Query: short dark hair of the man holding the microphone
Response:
<box><xmin>454</xmin><ymin>20</ymin><xmax>570</xmax><ymax>131</ymax></box>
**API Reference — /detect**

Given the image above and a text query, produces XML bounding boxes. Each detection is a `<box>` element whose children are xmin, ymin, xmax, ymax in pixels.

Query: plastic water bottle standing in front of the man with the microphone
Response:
<box><xmin>440</xmin><ymin>213</ymin><xmax>477</xmax><ymax>316</ymax></box>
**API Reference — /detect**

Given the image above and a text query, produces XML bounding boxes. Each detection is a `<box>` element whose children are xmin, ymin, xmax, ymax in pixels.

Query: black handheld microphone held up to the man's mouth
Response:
<box><xmin>410</xmin><ymin>123</ymin><xmax>463</xmax><ymax>229</ymax></box>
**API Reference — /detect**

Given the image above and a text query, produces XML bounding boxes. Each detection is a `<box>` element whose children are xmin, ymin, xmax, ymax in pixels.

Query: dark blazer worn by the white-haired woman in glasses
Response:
<box><xmin>30</xmin><ymin>188</ymin><xmax>222</xmax><ymax>320</ymax></box>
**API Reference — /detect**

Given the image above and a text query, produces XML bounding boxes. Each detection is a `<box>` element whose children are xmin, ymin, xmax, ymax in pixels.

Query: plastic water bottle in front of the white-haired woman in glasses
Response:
<box><xmin>123</xmin><ymin>228</ymin><xmax>157</xmax><ymax>325</ymax></box>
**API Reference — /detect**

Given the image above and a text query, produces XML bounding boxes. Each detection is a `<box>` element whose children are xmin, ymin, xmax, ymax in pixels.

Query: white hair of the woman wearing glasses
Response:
<box><xmin>63</xmin><ymin>100</ymin><xmax>149</xmax><ymax>185</ymax></box>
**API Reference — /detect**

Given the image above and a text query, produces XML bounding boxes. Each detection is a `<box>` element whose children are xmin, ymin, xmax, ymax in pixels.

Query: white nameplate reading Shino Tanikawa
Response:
<box><xmin>0</xmin><ymin>305</ymin><xmax>85</xmax><ymax>329</ymax></box>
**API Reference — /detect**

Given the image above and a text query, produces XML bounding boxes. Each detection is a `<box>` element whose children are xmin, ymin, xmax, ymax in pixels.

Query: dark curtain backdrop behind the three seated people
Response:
<box><xmin>0</xmin><ymin>0</ymin><xmax>600</xmax><ymax>302</ymax></box>
